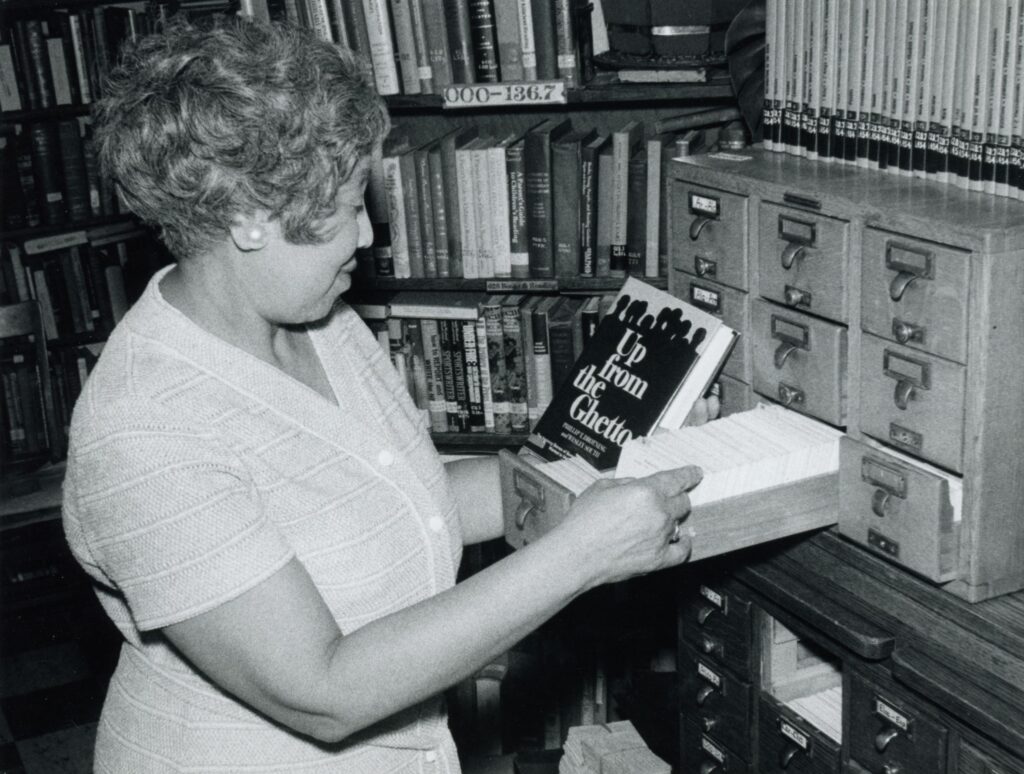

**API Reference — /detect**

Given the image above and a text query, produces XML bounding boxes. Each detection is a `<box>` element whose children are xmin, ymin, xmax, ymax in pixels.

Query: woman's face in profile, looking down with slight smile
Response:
<box><xmin>245</xmin><ymin>159</ymin><xmax>373</xmax><ymax>325</ymax></box>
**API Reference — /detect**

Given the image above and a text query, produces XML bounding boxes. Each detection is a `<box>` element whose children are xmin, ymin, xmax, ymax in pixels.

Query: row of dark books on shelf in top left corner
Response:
<box><xmin>0</xmin><ymin>2</ymin><xmax>168</xmax><ymax>112</ymax></box>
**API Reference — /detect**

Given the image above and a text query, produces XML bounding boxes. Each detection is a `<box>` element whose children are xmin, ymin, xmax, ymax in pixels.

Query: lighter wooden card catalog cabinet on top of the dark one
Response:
<box><xmin>669</xmin><ymin>149</ymin><xmax>1024</xmax><ymax>602</ymax></box>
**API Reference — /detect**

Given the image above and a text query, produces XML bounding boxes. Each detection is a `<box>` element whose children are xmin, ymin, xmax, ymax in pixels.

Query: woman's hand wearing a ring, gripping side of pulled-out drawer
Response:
<box><xmin>554</xmin><ymin>466</ymin><xmax>702</xmax><ymax>587</ymax></box>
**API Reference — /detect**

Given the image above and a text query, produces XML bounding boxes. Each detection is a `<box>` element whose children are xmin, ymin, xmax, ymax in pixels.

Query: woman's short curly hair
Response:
<box><xmin>93</xmin><ymin>17</ymin><xmax>390</xmax><ymax>259</ymax></box>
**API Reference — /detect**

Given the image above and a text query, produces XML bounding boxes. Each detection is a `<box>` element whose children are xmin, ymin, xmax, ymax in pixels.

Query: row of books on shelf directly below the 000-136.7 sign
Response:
<box><xmin>362</xmin><ymin>118</ymin><xmax>701</xmax><ymax>278</ymax></box>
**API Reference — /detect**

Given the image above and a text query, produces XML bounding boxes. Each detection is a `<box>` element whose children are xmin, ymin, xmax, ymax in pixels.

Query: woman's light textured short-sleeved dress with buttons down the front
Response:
<box><xmin>63</xmin><ymin>269</ymin><xmax>462</xmax><ymax>774</ymax></box>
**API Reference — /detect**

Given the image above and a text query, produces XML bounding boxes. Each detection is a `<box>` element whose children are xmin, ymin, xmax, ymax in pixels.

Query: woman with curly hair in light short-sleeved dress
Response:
<box><xmin>65</xmin><ymin>15</ymin><xmax>699</xmax><ymax>774</ymax></box>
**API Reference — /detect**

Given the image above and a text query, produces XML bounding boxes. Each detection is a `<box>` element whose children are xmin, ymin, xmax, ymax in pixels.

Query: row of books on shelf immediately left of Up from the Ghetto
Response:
<box><xmin>352</xmin><ymin>291</ymin><xmax>611</xmax><ymax>434</ymax></box>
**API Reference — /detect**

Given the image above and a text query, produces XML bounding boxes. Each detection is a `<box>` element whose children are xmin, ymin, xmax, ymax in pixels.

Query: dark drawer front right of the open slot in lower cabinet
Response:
<box><xmin>848</xmin><ymin>673</ymin><xmax>947</xmax><ymax>774</ymax></box>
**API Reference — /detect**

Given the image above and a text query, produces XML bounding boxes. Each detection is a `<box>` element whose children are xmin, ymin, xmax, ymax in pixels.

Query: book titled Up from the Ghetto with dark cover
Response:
<box><xmin>526</xmin><ymin>277</ymin><xmax>737</xmax><ymax>471</ymax></box>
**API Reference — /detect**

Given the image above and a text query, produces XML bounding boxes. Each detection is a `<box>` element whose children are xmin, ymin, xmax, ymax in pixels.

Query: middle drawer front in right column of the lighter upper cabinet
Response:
<box><xmin>860</xmin><ymin>334</ymin><xmax>966</xmax><ymax>473</ymax></box>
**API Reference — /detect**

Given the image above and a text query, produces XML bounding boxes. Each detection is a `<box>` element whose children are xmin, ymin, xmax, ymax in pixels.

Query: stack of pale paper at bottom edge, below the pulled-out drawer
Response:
<box><xmin>558</xmin><ymin>721</ymin><xmax>672</xmax><ymax>774</ymax></box>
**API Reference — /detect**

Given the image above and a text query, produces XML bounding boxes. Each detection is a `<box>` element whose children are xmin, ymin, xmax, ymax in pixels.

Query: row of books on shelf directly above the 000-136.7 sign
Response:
<box><xmin>242</xmin><ymin>0</ymin><xmax>590</xmax><ymax>94</ymax></box>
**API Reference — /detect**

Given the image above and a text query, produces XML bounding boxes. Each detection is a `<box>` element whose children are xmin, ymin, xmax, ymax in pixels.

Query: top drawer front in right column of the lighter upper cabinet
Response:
<box><xmin>861</xmin><ymin>228</ymin><xmax>971</xmax><ymax>362</ymax></box>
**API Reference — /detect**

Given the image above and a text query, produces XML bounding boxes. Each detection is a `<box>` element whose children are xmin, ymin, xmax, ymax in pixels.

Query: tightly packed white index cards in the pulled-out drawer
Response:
<box><xmin>615</xmin><ymin>404</ymin><xmax>843</xmax><ymax>507</ymax></box>
